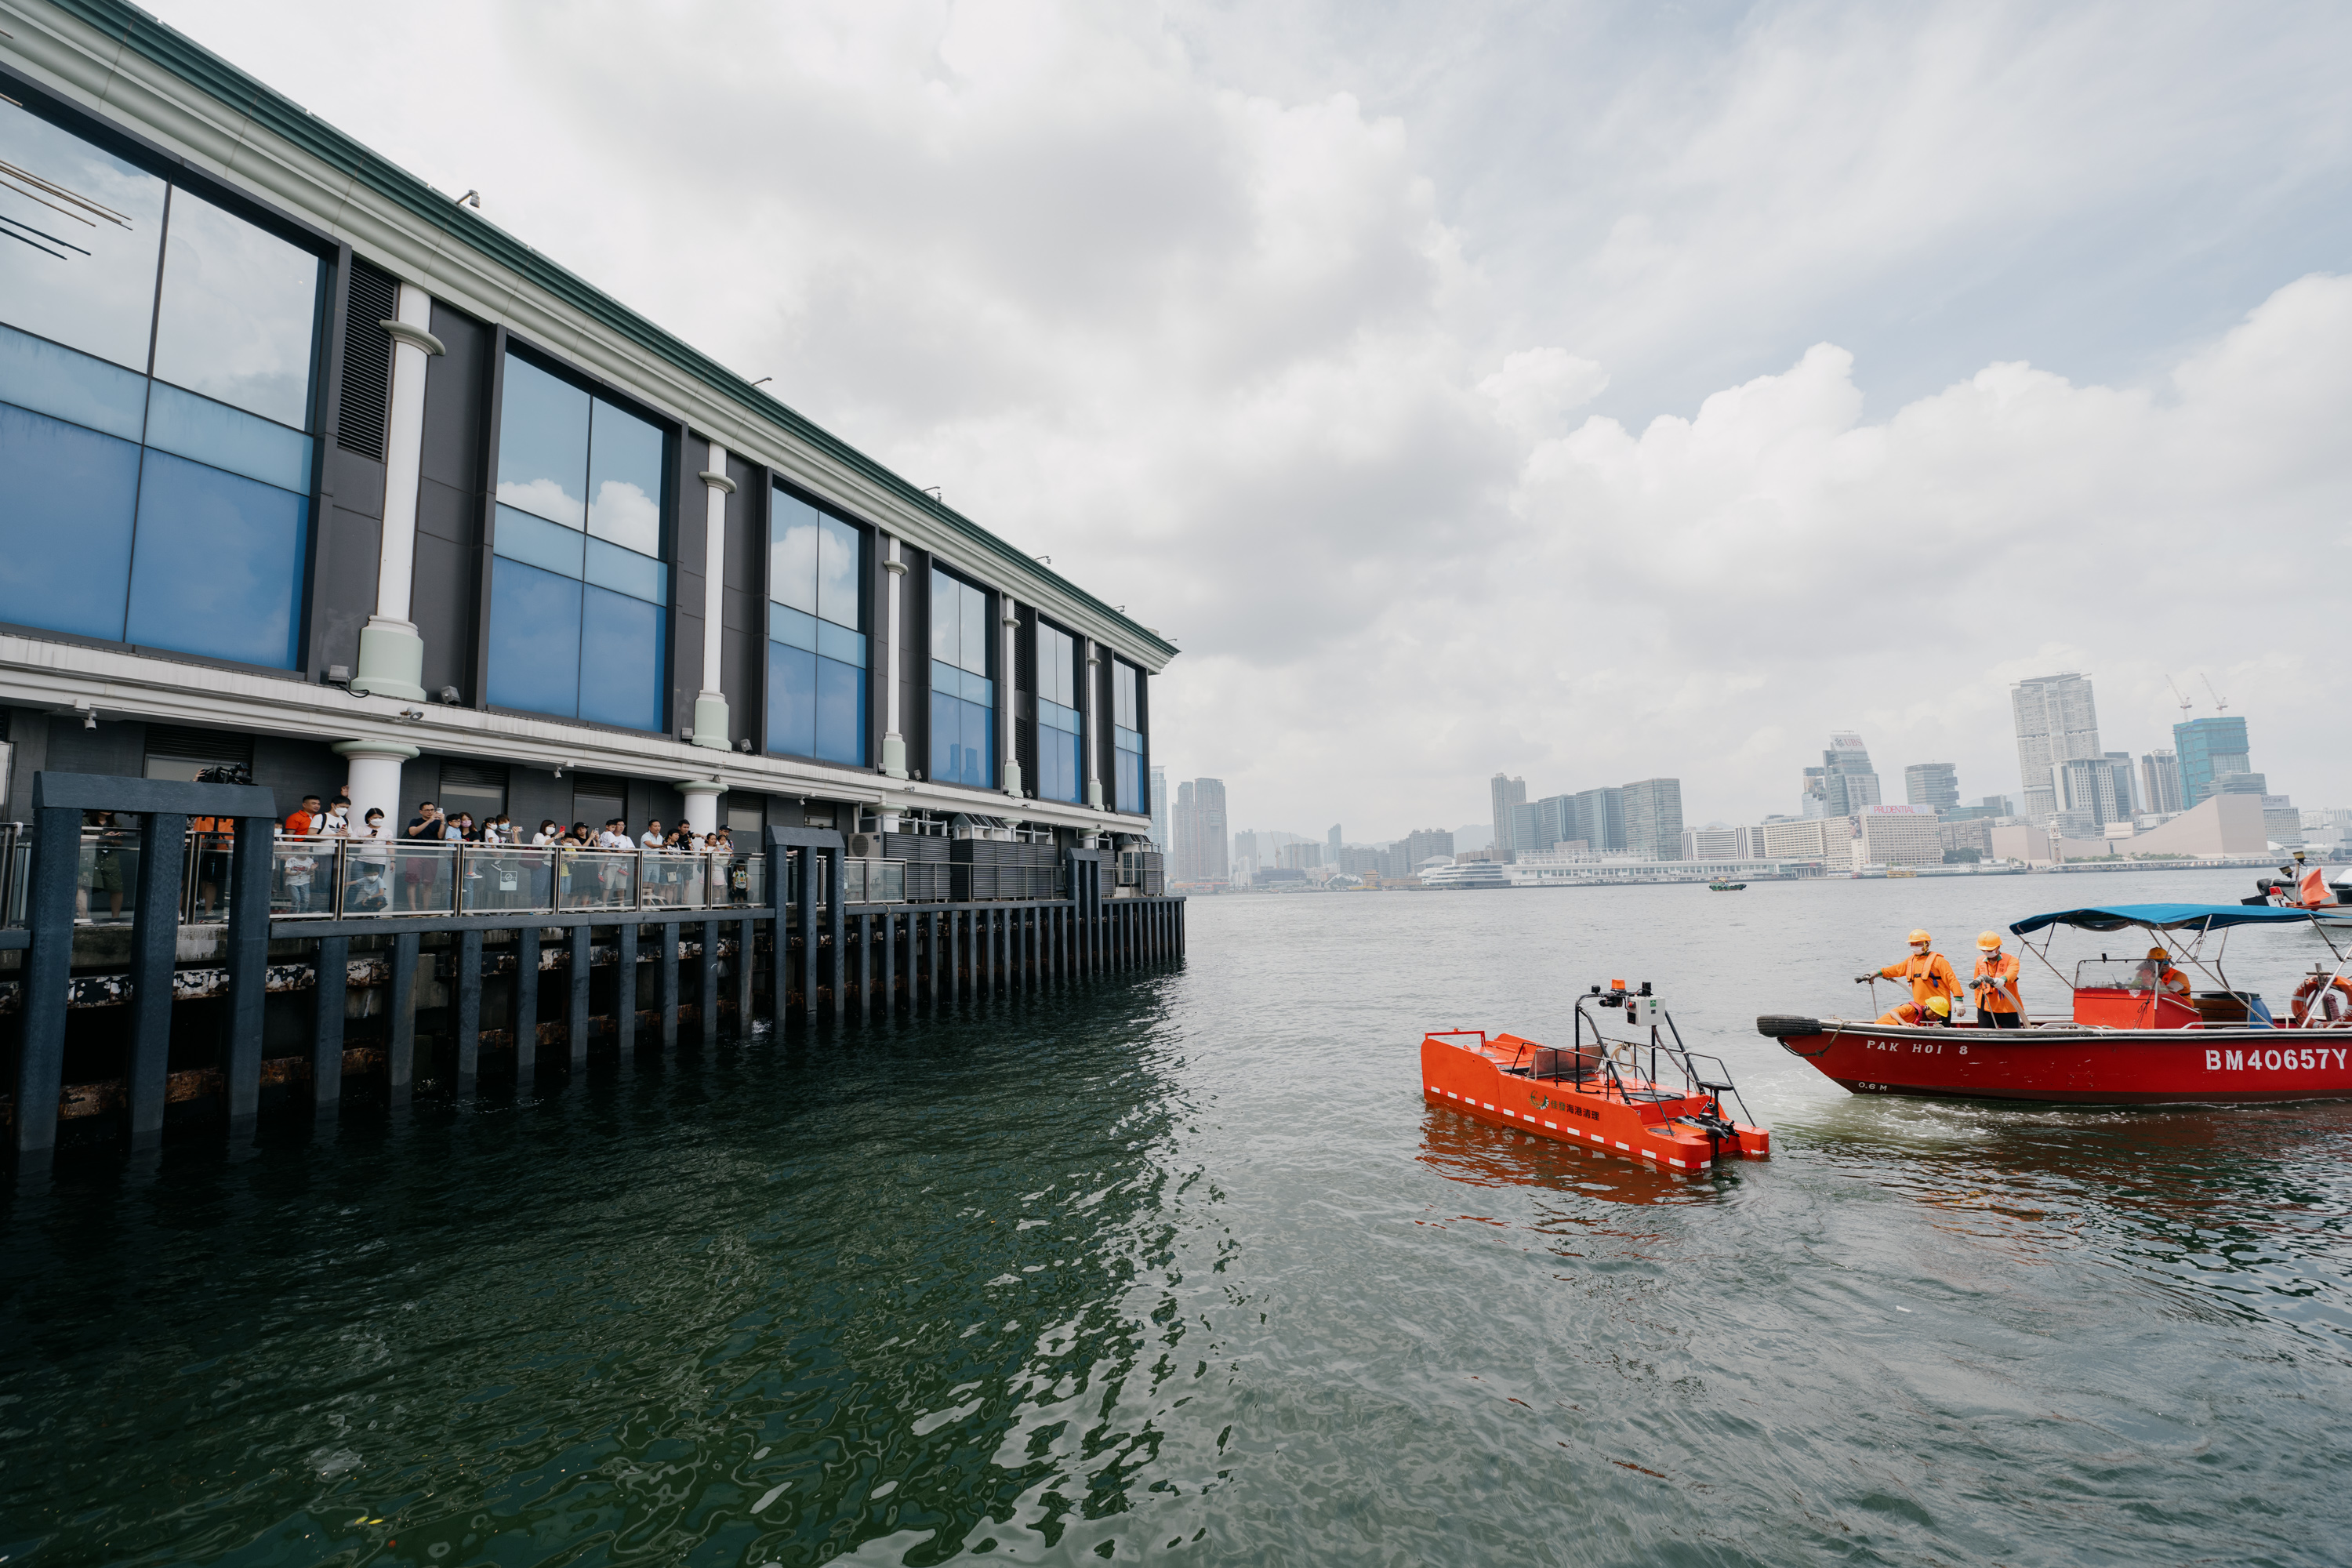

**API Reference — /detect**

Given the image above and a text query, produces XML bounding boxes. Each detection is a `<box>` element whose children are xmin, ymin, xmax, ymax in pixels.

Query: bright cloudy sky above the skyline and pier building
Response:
<box><xmin>165</xmin><ymin>0</ymin><xmax>2352</xmax><ymax>841</ymax></box>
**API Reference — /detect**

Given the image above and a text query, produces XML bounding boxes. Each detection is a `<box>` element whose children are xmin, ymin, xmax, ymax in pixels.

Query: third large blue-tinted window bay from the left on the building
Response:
<box><xmin>767</xmin><ymin>487</ymin><xmax>868</xmax><ymax>767</ymax></box>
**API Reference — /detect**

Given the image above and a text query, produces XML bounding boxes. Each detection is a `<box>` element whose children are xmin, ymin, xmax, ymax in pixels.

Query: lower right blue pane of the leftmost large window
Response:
<box><xmin>122</xmin><ymin>452</ymin><xmax>310</xmax><ymax>670</ymax></box>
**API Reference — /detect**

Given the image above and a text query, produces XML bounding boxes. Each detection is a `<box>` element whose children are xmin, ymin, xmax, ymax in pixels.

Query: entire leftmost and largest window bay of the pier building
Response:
<box><xmin>0</xmin><ymin>103</ymin><xmax>325</xmax><ymax>668</ymax></box>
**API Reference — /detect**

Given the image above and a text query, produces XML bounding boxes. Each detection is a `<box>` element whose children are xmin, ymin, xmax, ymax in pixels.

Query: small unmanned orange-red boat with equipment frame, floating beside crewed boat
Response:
<box><xmin>1421</xmin><ymin>980</ymin><xmax>1771</xmax><ymax>1171</ymax></box>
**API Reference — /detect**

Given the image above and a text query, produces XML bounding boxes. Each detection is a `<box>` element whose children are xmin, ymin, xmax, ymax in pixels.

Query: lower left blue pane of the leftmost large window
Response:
<box><xmin>0</xmin><ymin>405</ymin><xmax>139</xmax><ymax>640</ymax></box>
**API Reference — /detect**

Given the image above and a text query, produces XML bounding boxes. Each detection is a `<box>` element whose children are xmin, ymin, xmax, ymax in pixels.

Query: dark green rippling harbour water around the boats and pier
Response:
<box><xmin>0</xmin><ymin>872</ymin><xmax>2352</xmax><ymax>1568</ymax></box>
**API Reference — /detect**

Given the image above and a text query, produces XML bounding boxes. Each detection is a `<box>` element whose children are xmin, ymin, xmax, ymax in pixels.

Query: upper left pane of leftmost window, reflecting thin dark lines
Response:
<box><xmin>0</xmin><ymin>101</ymin><xmax>165</xmax><ymax>371</ymax></box>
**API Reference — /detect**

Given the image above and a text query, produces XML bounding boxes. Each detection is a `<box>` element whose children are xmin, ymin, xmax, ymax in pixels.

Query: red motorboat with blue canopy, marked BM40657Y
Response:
<box><xmin>1757</xmin><ymin>902</ymin><xmax>2352</xmax><ymax>1105</ymax></box>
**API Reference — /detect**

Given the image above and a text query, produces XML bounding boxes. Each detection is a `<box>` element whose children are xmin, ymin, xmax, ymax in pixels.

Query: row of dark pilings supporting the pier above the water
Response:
<box><xmin>0</xmin><ymin>771</ymin><xmax>1183</xmax><ymax>1171</ymax></box>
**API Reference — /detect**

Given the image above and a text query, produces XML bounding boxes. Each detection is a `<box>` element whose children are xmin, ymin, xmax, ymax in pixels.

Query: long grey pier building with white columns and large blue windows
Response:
<box><xmin>0</xmin><ymin>0</ymin><xmax>1176</xmax><ymax>1171</ymax></box>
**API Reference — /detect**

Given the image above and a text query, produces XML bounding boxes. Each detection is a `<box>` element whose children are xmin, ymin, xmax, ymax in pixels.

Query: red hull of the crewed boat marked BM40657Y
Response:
<box><xmin>1778</xmin><ymin>1022</ymin><xmax>2352</xmax><ymax>1105</ymax></box>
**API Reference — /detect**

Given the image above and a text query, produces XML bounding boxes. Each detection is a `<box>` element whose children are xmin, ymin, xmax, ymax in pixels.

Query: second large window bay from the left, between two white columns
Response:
<box><xmin>489</xmin><ymin>355</ymin><xmax>670</xmax><ymax>729</ymax></box>
